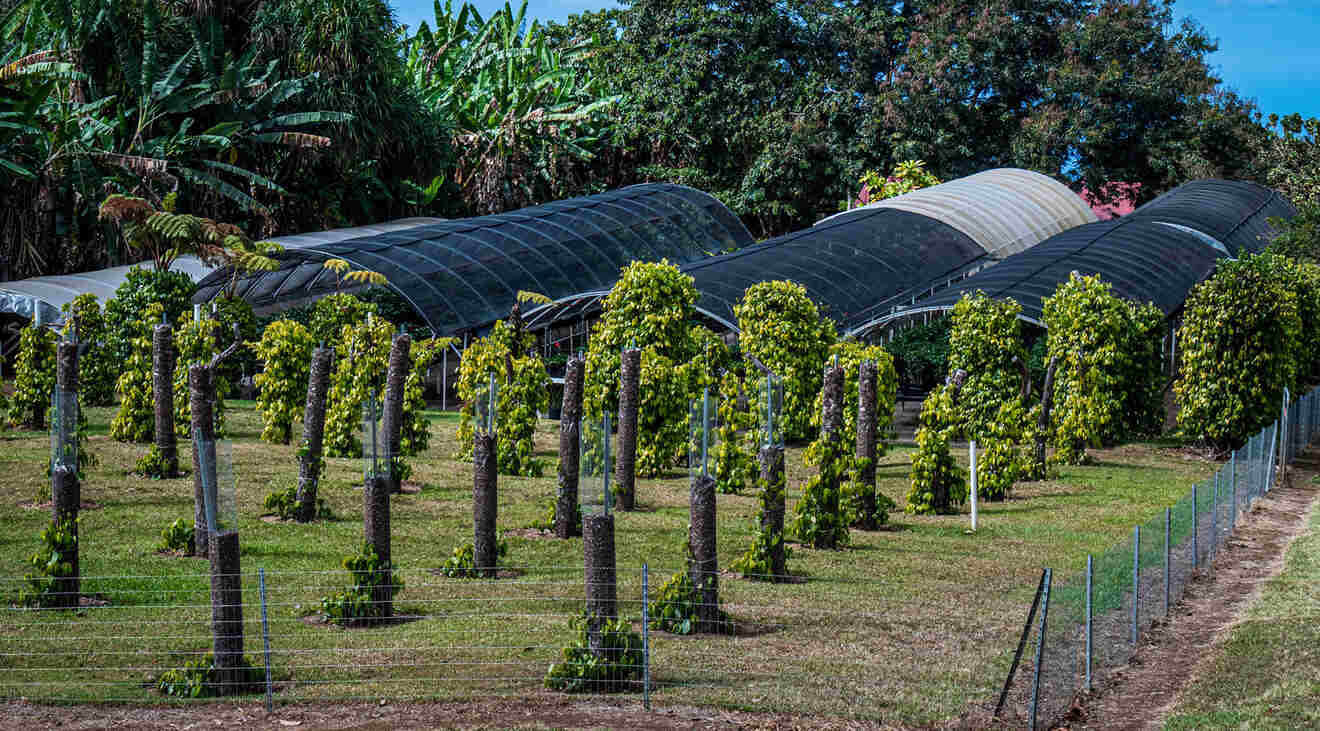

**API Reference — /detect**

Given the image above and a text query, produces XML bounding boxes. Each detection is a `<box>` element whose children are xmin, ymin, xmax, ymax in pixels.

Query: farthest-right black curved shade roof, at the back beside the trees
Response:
<box><xmin>1125</xmin><ymin>179</ymin><xmax>1298</xmax><ymax>256</ymax></box>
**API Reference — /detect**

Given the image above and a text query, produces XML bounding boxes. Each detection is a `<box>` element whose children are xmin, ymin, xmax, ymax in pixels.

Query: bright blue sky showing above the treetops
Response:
<box><xmin>391</xmin><ymin>0</ymin><xmax>1320</xmax><ymax>117</ymax></box>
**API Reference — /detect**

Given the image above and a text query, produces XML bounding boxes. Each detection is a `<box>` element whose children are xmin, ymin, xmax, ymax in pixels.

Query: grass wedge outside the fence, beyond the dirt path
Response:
<box><xmin>1164</xmin><ymin>480</ymin><xmax>1320</xmax><ymax>730</ymax></box>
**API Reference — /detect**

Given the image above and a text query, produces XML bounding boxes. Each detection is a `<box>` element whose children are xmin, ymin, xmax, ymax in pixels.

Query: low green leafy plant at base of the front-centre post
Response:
<box><xmin>545</xmin><ymin>612</ymin><xmax>644</xmax><ymax>693</ymax></box>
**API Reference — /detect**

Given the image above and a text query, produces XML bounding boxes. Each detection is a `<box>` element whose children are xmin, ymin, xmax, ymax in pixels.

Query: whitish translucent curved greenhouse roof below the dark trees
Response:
<box><xmin>817</xmin><ymin>168</ymin><xmax>1097</xmax><ymax>259</ymax></box>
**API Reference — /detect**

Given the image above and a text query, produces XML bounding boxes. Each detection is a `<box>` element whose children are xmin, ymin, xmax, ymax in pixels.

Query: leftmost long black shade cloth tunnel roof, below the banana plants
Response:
<box><xmin>193</xmin><ymin>183</ymin><xmax>754</xmax><ymax>335</ymax></box>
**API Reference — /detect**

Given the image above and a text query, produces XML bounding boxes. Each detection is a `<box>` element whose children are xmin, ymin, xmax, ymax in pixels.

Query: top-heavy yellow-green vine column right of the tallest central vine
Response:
<box><xmin>734</xmin><ymin>281</ymin><xmax>837</xmax><ymax>441</ymax></box>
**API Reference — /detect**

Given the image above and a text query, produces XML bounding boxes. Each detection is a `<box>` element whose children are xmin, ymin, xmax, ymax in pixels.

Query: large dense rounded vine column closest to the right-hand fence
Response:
<box><xmin>1173</xmin><ymin>253</ymin><xmax>1303</xmax><ymax>450</ymax></box>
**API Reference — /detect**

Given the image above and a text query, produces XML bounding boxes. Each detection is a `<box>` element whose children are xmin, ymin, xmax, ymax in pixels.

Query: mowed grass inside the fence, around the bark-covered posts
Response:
<box><xmin>0</xmin><ymin>401</ymin><xmax>1212</xmax><ymax>723</ymax></box>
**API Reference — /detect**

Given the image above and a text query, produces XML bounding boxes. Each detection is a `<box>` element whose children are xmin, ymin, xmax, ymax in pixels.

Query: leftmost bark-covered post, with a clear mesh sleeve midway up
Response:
<box><xmin>50</xmin><ymin>342</ymin><xmax>82</xmax><ymax>607</ymax></box>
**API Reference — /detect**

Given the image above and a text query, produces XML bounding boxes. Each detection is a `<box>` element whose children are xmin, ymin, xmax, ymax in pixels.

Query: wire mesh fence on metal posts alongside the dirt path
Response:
<box><xmin>997</xmin><ymin>391</ymin><xmax>1320</xmax><ymax>728</ymax></box>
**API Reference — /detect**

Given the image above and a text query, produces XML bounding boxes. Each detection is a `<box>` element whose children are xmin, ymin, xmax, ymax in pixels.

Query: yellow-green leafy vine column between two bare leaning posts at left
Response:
<box><xmin>325</xmin><ymin>318</ymin><xmax>395</xmax><ymax>457</ymax></box>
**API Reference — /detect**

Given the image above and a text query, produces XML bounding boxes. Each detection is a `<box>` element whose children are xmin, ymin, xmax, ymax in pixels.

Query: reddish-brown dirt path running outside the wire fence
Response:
<box><xmin>1069</xmin><ymin>453</ymin><xmax>1320</xmax><ymax>730</ymax></box>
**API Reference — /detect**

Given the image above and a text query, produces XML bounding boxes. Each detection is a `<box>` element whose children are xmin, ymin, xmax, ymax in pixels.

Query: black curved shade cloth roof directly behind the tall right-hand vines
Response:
<box><xmin>858</xmin><ymin>216</ymin><xmax>1225</xmax><ymax>325</ymax></box>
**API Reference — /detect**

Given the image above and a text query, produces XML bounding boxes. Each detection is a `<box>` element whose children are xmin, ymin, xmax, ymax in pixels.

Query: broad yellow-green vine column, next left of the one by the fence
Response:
<box><xmin>1043</xmin><ymin>276</ymin><xmax>1163</xmax><ymax>464</ymax></box>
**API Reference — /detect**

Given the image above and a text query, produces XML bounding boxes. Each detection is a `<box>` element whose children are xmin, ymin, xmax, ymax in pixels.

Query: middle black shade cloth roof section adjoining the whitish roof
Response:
<box><xmin>681</xmin><ymin>207</ymin><xmax>989</xmax><ymax>326</ymax></box>
